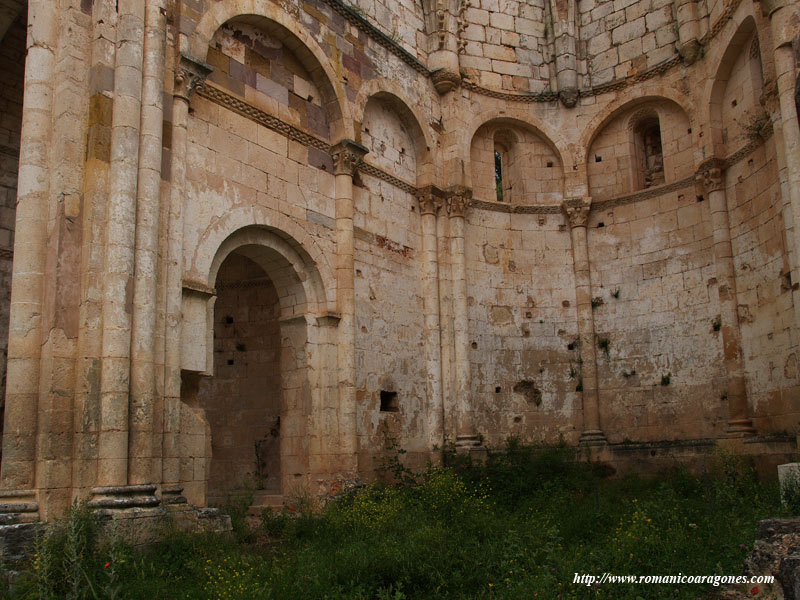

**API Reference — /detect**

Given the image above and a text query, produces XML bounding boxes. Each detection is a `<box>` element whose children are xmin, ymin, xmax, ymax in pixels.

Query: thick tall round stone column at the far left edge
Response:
<box><xmin>0</xmin><ymin>0</ymin><xmax>59</xmax><ymax>518</ymax></box>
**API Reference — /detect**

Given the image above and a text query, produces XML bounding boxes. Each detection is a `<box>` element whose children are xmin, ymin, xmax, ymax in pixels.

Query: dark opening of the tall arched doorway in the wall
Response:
<box><xmin>197</xmin><ymin>250</ymin><xmax>296</xmax><ymax>506</ymax></box>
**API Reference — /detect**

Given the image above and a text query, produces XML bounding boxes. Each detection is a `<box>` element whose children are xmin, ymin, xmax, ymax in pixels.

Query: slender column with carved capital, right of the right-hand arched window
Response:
<box><xmin>697</xmin><ymin>158</ymin><xmax>756</xmax><ymax>437</ymax></box>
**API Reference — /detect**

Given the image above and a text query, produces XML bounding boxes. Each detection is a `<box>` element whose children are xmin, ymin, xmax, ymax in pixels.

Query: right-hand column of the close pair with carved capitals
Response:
<box><xmin>447</xmin><ymin>186</ymin><xmax>480</xmax><ymax>452</ymax></box>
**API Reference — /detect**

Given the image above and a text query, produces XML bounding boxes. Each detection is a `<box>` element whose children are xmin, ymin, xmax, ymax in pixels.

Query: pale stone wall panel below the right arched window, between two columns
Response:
<box><xmin>589</xmin><ymin>190</ymin><xmax>728</xmax><ymax>442</ymax></box>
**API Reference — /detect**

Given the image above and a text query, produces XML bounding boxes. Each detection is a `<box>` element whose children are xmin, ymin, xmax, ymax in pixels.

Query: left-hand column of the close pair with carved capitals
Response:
<box><xmin>418</xmin><ymin>185</ymin><xmax>445</xmax><ymax>449</ymax></box>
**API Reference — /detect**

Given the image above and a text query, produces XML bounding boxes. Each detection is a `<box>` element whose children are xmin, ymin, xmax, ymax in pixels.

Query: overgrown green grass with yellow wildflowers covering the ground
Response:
<box><xmin>6</xmin><ymin>440</ymin><xmax>786</xmax><ymax>600</ymax></box>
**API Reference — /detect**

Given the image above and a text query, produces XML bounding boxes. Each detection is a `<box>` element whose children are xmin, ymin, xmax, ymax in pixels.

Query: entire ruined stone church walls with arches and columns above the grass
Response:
<box><xmin>0</xmin><ymin>0</ymin><xmax>800</xmax><ymax>572</ymax></box>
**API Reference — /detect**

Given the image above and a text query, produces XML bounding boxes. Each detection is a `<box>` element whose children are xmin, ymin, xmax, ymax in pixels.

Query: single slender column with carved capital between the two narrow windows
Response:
<box><xmin>562</xmin><ymin>198</ymin><xmax>607</xmax><ymax>446</ymax></box>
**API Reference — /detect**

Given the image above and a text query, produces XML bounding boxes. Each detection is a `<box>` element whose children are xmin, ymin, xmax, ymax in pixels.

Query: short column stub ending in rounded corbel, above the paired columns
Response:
<box><xmin>428</xmin><ymin>0</ymin><xmax>467</xmax><ymax>95</ymax></box>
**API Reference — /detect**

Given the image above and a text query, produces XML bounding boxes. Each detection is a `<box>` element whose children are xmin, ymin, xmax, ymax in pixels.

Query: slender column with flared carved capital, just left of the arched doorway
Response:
<box><xmin>161</xmin><ymin>55</ymin><xmax>211</xmax><ymax>504</ymax></box>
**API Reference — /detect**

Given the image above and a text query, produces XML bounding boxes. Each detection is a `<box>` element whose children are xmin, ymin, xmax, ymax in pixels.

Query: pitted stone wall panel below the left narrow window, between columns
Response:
<box><xmin>466</xmin><ymin>210</ymin><xmax>581</xmax><ymax>446</ymax></box>
